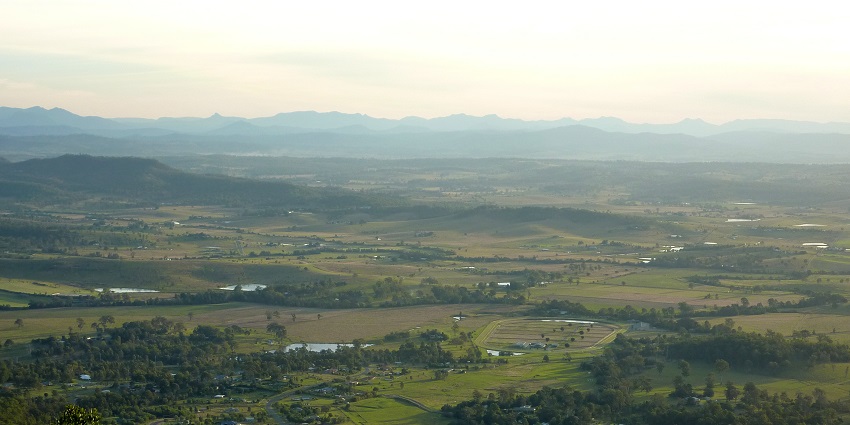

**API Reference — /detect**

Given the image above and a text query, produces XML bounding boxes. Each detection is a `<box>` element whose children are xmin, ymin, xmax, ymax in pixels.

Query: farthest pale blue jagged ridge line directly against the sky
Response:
<box><xmin>0</xmin><ymin>106</ymin><xmax>850</xmax><ymax>137</ymax></box>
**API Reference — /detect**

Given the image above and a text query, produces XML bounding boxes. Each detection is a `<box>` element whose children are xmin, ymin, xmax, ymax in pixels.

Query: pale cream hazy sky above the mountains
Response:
<box><xmin>0</xmin><ymin>0</ymin><xmax>850</xmax><ymax>123</ymax></box>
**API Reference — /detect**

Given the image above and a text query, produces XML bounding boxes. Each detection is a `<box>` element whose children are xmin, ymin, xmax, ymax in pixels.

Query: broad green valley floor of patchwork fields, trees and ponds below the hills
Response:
<box><xmin>0</xmin><ymin>160</ymin><xmax>850</xmax><ymax>425</ymax></box>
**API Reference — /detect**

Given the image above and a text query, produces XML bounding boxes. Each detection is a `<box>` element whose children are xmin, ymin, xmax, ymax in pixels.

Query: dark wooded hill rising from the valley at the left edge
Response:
<box><xmin>0</xmin><ymin>155</ymin><xmax>390</xmax><ymax>209</ymax></box>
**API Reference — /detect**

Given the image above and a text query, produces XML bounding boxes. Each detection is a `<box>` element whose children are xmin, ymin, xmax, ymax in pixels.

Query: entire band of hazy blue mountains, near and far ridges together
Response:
<box><xmin>0</xmin><ymin>107</ymin><xmax>850</xmax><ymax>163</ymax></box>
